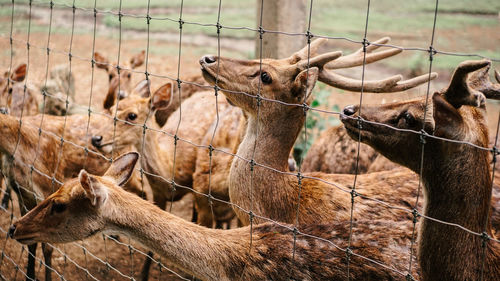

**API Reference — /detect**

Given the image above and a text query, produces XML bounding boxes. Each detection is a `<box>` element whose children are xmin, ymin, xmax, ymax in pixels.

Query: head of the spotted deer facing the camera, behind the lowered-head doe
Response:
<box><xmin>92</xmin><ymin>80</ymin><xmax>172</xmax><ymax>153</ymax></box>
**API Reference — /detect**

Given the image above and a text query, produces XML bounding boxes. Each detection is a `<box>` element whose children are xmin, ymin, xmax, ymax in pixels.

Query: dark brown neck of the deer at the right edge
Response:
<box><xmin>419</xmin><ymin>142</ymin><xmax>500</xmax><ymax>280</ymax></box>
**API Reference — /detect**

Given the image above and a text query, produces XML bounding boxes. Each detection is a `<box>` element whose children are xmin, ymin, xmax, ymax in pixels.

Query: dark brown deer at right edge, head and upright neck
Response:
<box><xmin>341</xmin><ymin>60</ymin><xmax>500</xmax><ymax>280</ymax></box>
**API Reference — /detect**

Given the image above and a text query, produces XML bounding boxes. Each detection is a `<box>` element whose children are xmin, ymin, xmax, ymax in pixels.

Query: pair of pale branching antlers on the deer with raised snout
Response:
<box><xmin>288</xmin><ymin>37</ymin><xmax>437</xmax><ymax>93</ymax></box>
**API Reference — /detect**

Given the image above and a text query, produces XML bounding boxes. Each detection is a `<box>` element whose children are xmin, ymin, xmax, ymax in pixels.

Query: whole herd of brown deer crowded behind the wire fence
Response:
<box><xmin>0</xmin><ymin>38</ymin><xmax>500</xmax><ymax>280</ymax></box>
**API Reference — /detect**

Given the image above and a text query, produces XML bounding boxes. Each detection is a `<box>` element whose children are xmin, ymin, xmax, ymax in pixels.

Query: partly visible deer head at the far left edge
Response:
<box><xmin>0</xmin><ymin>63</ymin><xmax>26</xmax><ymax>114</ymax></box>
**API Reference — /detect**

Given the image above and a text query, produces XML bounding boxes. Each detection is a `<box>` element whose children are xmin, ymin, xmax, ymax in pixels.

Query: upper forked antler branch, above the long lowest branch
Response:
<box><xmin>325</xmin><ymin>37</ymin><xmax>403</xmax><ymax>69</ymax></box>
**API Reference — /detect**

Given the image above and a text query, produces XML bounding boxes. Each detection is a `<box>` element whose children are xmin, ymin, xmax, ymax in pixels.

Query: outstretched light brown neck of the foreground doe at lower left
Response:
<box><xmin>104</xmin><ymin>185</ymin><xmax>250</xmax><ymax>280</ymax></box>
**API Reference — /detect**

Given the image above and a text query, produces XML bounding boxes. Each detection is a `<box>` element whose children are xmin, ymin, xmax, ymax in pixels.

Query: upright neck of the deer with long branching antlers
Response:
<box><xmin>229</xmin><ymin>108</ymin><xmax>303</xmax><ymax>224</ymax></box>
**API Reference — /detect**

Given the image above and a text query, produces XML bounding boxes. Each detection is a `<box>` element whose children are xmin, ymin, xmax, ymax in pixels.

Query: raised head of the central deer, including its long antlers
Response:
<box><xmin>200</xmin><ymin>38</ymin><xmax>436</xmax><ymax>121</ymax></box>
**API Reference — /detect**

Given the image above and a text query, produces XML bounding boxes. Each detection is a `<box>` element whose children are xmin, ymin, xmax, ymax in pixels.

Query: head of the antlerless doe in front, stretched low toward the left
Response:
<box><xmin>8</xmin><ymin>152</ymin><xmax>139</xmax><ymax>244</ymax></box>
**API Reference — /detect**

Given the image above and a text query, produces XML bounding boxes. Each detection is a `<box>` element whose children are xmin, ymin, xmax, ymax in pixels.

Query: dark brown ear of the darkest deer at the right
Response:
<box><xmin>432</xmin><ymin>93</ymin><xmax>463</xmax><ymax>138</ymax></box>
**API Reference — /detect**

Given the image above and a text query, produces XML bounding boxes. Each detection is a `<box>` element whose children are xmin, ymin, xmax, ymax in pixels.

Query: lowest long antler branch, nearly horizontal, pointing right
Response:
<box><xmin>318</xmin><ymin>70</ymin><xmax>437</xmax><ymax>93</ymax></box>
